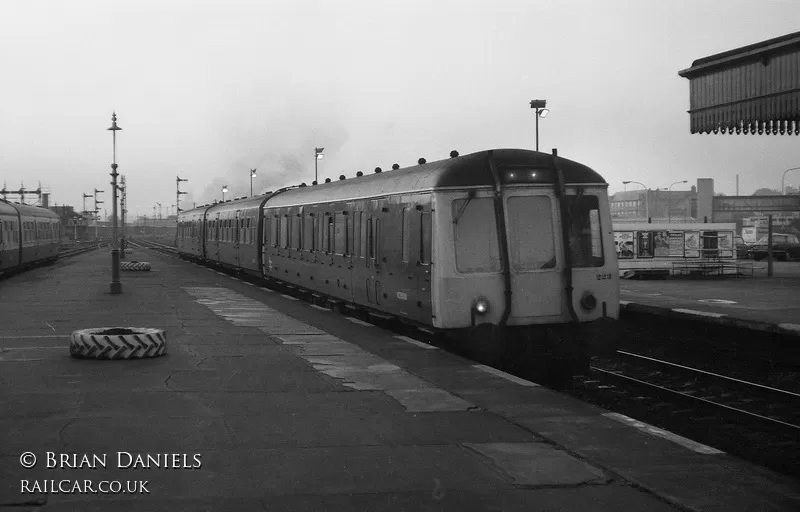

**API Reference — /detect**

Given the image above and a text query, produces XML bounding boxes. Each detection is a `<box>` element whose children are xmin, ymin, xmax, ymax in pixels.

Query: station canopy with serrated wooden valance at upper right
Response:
<box><xmin>678</xmin><ymin>32</ymin><xmax>800</xmax><ymax>135</ymax></box>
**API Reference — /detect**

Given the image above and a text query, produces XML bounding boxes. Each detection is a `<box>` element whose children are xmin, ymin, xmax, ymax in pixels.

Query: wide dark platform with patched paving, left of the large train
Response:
<box><xmin>0</xmin><ymin>249</ymin><xmax>800</xmax><ymax>512</ymax></box>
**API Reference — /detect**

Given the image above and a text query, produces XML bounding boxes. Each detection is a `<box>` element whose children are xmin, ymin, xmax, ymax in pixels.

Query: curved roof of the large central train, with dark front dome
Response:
<box><xmin>178</xmin><ymin>149</ymin><xmax>606</xmax><ymax>214</ymax></box>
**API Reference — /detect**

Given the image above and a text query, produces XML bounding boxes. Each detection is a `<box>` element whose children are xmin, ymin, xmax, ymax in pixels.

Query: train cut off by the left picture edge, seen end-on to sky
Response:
<box><xmin>0</xmin><ymin>199</ymin><xmax>61</xmax><ymax>274</ymax></box>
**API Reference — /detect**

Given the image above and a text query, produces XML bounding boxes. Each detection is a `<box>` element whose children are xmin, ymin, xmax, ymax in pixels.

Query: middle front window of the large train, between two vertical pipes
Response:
<box><xmin>507</xmin><ymin>196</ymin><xmax>556</xmax><ymax>271</ymax></box>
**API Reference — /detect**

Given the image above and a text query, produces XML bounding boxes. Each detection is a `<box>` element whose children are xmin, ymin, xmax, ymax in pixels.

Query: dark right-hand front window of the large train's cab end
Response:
<box><xmin>566</xmin><ymin>195</ymin><xmax>605</xmax><ymax>267</ymax></box>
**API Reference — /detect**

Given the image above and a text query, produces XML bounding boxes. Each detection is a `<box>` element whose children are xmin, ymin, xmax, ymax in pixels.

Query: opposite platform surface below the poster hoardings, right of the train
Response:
<box><xmin>620</xmin><ymin>261</ymin><xmax>800</xmax><ymax>336</ymax></box>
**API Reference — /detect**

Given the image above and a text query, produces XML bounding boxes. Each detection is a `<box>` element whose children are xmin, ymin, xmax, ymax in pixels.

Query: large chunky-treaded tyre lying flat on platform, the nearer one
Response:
<box><xmin>69</xmin><ymin>327</ymin><xmax>167</xmax><ymax>359</ymax></box>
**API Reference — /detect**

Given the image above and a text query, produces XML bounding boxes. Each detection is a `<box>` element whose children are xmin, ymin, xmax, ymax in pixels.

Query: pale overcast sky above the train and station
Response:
<box><xmin>0</xmin><ymin>0</ymin><xmax>800</xmax><ymax>218</ymax></box>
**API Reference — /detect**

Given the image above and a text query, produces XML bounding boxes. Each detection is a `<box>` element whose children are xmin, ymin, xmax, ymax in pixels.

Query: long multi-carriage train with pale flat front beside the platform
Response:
<box><xmin>177</xmin><ymin>149</ymin><xmax>619</xmax><ymax>375</ymax></box>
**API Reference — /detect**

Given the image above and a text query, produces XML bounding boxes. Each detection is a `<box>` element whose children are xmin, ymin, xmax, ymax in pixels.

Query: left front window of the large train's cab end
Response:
<box><xmin>452</xmin><ymin>197</ymin><xmax>501</xmax><ymax>272</ymax></box>
